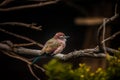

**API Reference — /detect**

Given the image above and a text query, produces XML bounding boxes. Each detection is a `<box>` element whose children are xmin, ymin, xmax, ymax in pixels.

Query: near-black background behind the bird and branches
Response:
<box><xmin>0</xmin><ymin>0</ymin><xmax>120</xmax><ymax>80</ymax></box>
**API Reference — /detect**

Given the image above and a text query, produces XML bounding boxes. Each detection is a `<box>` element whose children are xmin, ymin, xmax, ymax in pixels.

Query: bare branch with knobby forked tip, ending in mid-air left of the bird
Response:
<box><xmin>0</xmin><ymin>22</ymin><xmax>42</xmax><ymax>31</ymax></box>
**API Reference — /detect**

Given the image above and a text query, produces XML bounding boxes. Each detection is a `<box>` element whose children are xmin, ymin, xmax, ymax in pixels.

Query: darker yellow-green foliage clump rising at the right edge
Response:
<box><xmin>106</xmin><ymin>50</ymin><xmax>120</xmax><ymax>80</ymax></box>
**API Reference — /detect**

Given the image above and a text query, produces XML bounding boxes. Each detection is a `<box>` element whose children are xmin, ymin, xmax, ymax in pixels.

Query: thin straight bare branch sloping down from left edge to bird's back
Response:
<box><xmin>0</xmin><ymin>28</ymin><xmax>43</xmax><ymax>47</ymax></box>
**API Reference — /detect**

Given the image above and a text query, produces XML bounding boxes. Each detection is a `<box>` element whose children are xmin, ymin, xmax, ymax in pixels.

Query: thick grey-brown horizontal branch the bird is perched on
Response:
<box><xmin>0</xmin><ymin>43</ymin><xmax>120</xmax><ymax>60</ymax></box>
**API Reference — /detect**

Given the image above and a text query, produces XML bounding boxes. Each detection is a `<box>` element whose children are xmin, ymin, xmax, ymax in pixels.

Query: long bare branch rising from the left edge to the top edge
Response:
<box><xmin>0</xmin><ymin>0</ymin><xmax>59</xmax><ymax>11</ymax></box>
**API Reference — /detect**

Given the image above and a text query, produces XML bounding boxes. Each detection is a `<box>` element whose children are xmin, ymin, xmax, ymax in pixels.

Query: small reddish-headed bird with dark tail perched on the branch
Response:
<box><xmin>32</xmin><ymin>32</ymin><xmax>69</xmax><ymax>64</ymax></box>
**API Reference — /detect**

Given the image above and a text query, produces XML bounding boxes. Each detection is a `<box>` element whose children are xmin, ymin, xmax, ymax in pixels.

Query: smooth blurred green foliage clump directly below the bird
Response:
<box><xmin>45</xmin><ymin>59</ymin><xmax>73</xmax><ymax>80</ymax></box>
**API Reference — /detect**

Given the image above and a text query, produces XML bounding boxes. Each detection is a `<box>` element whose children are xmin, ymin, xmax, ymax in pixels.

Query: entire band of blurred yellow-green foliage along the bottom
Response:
<box><xmin>44</xmin><ymin>48</ymin><xmax>120</xmax><ymax>80</ymax></box>
